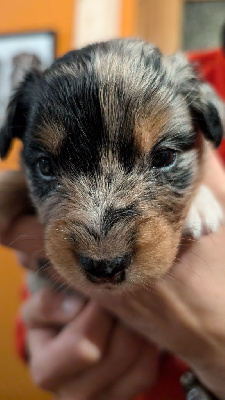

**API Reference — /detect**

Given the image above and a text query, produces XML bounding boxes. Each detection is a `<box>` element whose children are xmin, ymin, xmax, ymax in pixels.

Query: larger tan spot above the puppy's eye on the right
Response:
<box><xmin>134</xmin><ymin>107</ymin><xmax>171</xmax><ymax>154</ymax></box>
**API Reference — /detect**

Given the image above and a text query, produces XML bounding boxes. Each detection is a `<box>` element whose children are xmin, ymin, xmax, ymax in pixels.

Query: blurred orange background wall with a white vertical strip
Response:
<box><xmin>0</xmin><ymin>0</ymin><xmax>225</xmax><ymax>400</ymax></box>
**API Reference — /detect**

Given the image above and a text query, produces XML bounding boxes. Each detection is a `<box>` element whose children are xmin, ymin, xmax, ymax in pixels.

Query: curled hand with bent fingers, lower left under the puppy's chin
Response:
<box><xmin>22</xmin><ymin>289</ymin><xmax>157</xmax><ymax>400</ymax></box>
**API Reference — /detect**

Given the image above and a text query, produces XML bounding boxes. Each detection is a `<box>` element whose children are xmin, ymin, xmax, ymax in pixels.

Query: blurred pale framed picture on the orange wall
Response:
<box><xmin>0</xmin><ymin>31</ymin><xmax>56</xmax><ymax>124</ymax></box>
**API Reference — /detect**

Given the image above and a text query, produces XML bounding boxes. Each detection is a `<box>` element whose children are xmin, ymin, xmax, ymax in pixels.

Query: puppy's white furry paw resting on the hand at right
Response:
<box><xmin>183</xmin><ymin>185</ymin><xmax>224</xmax><ymax>239</ymax></box>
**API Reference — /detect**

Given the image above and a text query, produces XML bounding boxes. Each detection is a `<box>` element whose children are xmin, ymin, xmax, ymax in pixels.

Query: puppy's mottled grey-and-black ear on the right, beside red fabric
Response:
<box><xmin>167</xmin><ymin>53</ymin><xmax>225</xmax><ymax>147</ymax></box>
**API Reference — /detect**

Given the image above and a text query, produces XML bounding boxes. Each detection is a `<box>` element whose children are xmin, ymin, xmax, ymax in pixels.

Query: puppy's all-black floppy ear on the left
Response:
<box><xmin>0</xmin><ymin>70</ymin><xmax>41</xmax><ymax>158</ymax></box>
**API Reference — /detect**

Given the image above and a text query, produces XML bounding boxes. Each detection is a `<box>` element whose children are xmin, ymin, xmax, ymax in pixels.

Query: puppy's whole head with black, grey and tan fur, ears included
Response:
<box><xmin>0</xmin><ymin>40</ymin><xmax>222</xmax><ymax>291</ymax></box>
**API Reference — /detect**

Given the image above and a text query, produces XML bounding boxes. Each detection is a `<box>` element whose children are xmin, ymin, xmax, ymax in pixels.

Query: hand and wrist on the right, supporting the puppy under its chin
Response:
<box><xmin>92</xmin><ymin>152</ymin><xmax>225</xmax><ymax>399</ymax></box>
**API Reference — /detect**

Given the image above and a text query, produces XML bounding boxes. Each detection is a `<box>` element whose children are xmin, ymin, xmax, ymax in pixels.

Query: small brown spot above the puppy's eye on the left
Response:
<box><xmin>36</xmin><ymin>122</ymin><xmax>66</xmax><ymax>155</ymax></box>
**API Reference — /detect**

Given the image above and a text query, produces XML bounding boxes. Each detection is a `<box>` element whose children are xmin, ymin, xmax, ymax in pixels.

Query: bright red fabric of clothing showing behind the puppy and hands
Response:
<box><xmin>16</xmin><ymin>50</ymin><xmax>225</xmax><ymax>400</ymax></box>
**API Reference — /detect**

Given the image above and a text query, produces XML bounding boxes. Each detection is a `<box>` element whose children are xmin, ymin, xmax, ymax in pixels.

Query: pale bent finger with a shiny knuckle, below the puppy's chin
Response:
<box><xmin>28</xmin><ymin>296</ymin><xmax>113</xmax><ymax>391</ymax></box>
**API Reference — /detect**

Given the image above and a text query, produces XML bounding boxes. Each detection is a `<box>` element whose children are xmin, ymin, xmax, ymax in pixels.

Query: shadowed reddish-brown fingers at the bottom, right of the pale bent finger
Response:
<box><xmin>55</xmin><ymin>323</ymin><xmax>156</xmax><ymax>400</ymax></box>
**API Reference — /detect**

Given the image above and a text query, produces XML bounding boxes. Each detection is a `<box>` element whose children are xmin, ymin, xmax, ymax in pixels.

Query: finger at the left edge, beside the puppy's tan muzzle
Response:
<box><xmin>1</xmin><ymin>215</ymin><xmax>44</xmax><ymax>257</ymax></box>
